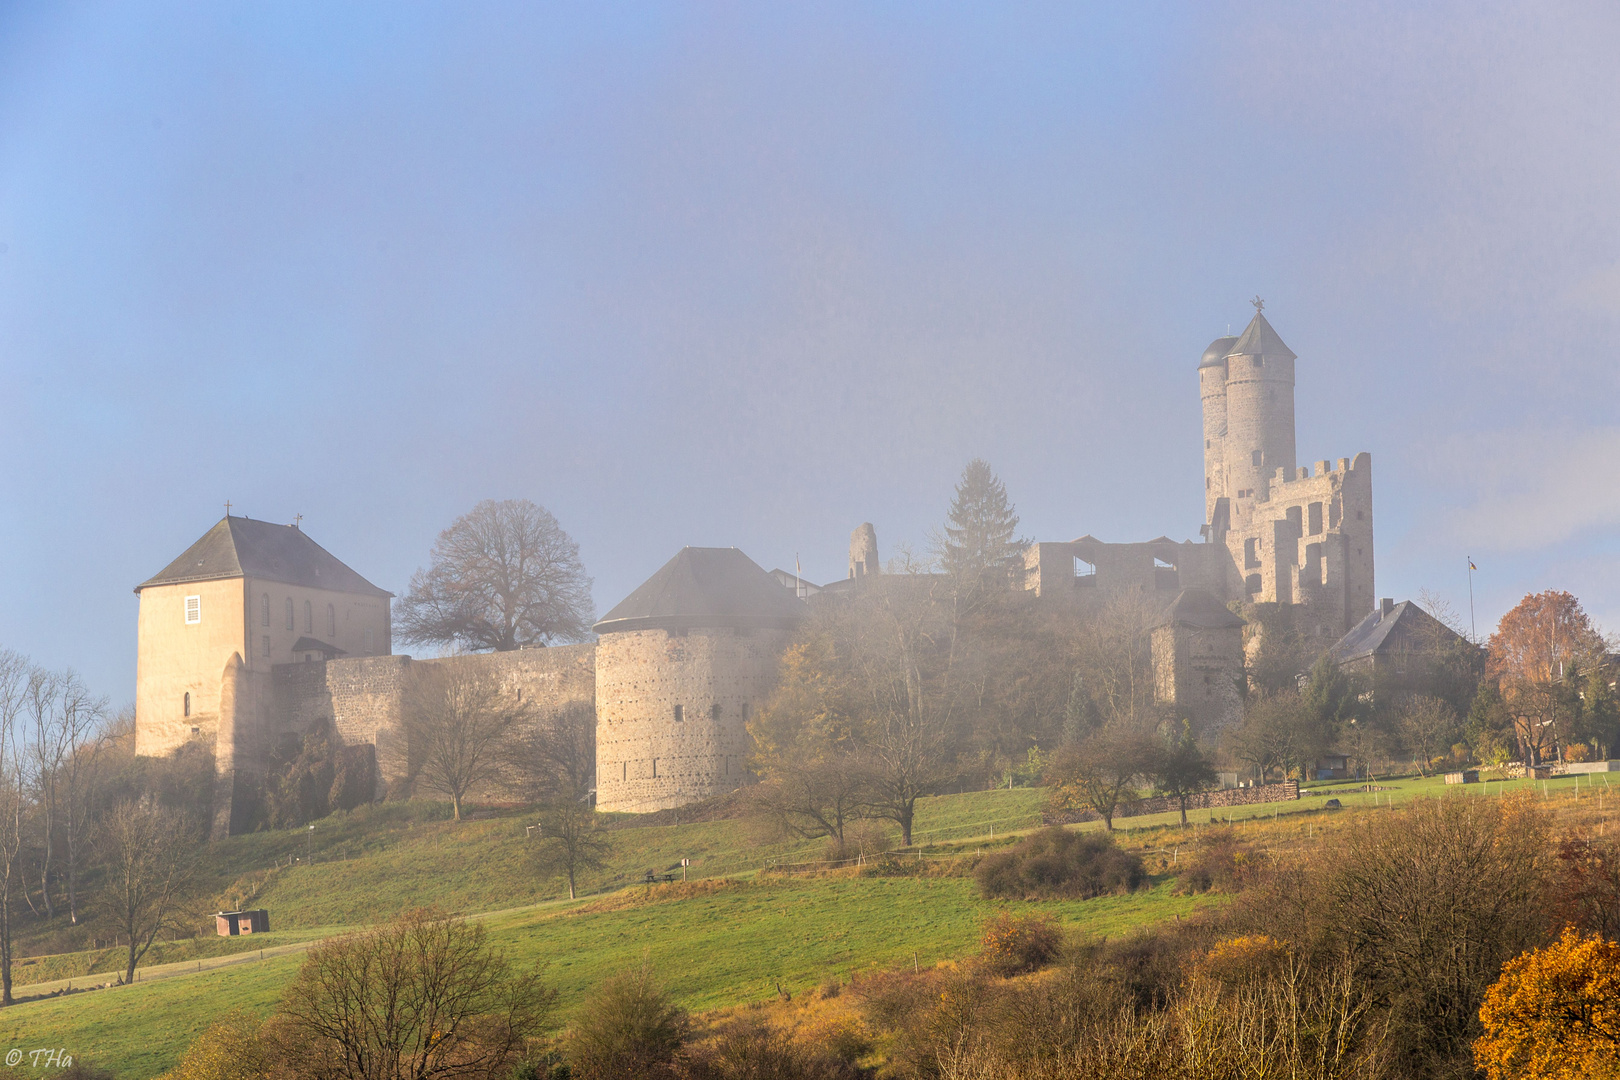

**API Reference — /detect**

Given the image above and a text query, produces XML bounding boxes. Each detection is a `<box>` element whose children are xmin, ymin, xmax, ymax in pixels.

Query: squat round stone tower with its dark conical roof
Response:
<box><xmin>595</xmin><ymin>547</ymin><xmax>807</xmax><ymax>813</ymax></box>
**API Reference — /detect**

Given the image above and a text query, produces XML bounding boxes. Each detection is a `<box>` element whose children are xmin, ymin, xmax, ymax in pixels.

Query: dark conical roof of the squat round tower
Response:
<box><xmin>593</xmin><ymin>547</ymin><xmax>808</xmax><ymax>633</ymax></box>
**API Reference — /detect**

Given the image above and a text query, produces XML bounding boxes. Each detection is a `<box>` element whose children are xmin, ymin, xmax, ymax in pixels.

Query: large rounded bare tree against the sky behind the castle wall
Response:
<box><xmin>394</xmin><ymin>499</ymin><xmax>591</xmax><ymax>651</ymax></box>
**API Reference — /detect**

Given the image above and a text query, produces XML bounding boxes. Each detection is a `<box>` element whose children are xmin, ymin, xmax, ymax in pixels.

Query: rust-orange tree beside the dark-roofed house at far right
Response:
<box><xmin>1486</xmin><ymin>589</ymin><xmax>1604</xmax><ymax>764</ymax></box>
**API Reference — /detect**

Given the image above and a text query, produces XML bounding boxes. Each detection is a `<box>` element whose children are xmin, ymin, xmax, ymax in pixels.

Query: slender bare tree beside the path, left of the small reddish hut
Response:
<box><xmin>99</xmin><ymin>800</ymin><xmax>196</xmax><ymax>983</ymax></box>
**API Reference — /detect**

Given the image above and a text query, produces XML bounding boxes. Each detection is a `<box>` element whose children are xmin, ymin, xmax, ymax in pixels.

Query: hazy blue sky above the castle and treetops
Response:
<box><xmin>0</xmin><ymin>2</ymin><xmax>1620</xmax><ymax>701</ymax></box>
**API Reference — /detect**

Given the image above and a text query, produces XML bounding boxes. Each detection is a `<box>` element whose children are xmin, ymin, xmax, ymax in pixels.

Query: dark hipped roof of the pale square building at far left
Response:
<box><xmin>134</xmin><ymin>517</ymin><xmax>394</xmax><ymax>597</ymax></box>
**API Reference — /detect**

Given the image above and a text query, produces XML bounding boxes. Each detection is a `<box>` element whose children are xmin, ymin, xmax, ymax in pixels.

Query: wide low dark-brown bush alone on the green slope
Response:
<box><xmin>975</xmin><ymin>827</ymin><xmax>1147</xmax><ymax>900</ymax></box>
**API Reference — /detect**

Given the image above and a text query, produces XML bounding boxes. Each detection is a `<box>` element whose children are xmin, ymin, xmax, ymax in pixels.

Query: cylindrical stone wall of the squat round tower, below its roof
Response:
<box><xmin>596</xmin><ymin>628</ymin><xmax>791</xmax><ymax>813</ymax></box>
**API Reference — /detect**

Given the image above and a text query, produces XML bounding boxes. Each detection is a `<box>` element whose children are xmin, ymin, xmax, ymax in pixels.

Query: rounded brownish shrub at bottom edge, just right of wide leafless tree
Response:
<box><xmin>567</xmin><ymin>963</ymin><xmax>692</xmax><ymax>1080</ymax></box>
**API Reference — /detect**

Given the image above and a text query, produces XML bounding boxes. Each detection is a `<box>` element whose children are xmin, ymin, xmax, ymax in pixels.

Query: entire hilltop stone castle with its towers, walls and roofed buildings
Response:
<box><xmin>136</xmin><ymin>301</ymin><xmax>1374</xmax><ymax>836</ymax></box>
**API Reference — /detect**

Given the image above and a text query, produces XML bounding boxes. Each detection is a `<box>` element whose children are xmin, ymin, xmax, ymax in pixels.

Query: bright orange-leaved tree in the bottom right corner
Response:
<box><xmin>1474</xmin><ymin>928</ymin><xmax>1620</xmax><ymax>1080</ymax></box>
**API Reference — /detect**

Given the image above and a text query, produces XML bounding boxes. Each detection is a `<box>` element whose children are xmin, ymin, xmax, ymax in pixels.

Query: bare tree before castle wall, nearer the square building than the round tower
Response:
<box><xmin>402</xmin><ymin>657</ymin><xmax>535</xmax><ymax>821</ymax></box>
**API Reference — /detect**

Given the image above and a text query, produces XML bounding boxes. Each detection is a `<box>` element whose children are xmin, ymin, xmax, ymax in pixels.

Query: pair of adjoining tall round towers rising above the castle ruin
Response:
<box><xmin>1199</xmin><ymin>300</ymin><xmax>1294</xmax><ymax>521</ymax></box>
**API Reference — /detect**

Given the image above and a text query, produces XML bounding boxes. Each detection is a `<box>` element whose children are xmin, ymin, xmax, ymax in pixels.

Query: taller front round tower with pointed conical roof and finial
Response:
<box><xmin>1204</xmin><ymin>301</ymin><xmax>1294</xmax><ymax>518</ymax></box>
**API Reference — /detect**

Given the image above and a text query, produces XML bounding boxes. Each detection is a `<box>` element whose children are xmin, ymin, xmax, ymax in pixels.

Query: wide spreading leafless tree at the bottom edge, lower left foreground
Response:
<box><xmin>266</xmin><ymin>912</ymin><xmax>556</xmax><ymax>1080</ymax></box>
